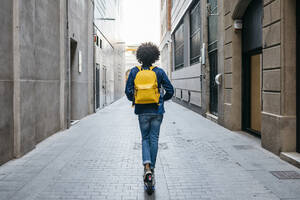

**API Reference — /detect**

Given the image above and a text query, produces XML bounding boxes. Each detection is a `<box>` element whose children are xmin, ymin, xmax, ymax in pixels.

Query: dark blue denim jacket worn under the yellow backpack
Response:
<box><xmin>125</xmin><ymin>67</ymin><xmax>174</xmax><ymax>115</ymax></box>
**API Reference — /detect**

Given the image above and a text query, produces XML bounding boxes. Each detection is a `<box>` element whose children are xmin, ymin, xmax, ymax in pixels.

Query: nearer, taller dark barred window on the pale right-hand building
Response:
<box><xmin>190</xmin><ymin>1</ymin><xmax>201</xmax><ymax>65</ymax></box>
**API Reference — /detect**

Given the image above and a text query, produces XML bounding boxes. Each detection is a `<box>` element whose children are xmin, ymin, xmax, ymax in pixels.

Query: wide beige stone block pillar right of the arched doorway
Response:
<box><xmin>262</xmin><ymin>0</ymin><xmax>296</xmax><ymax>154</ymax></box>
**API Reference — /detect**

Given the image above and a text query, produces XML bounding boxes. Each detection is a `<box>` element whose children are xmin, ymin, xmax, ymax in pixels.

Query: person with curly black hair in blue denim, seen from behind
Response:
<box><xmin>125</xmin><ymin>42</ymin><xmax>174</xmax><ymax>188</ymax></box>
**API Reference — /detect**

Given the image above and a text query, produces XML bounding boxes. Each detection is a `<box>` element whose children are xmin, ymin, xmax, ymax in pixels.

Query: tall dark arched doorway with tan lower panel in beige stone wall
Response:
<box><xmin>242</xmin><ymin>0</ymin><xmax>263</xmax><ymax>136</ymax></box>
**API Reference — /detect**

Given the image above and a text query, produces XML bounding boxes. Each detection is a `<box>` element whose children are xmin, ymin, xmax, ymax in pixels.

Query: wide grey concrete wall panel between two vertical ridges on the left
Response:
<box><xmin>19</xmin><ymin>0</ymin><xmax>60</xmax><ymax>154</ymax></box>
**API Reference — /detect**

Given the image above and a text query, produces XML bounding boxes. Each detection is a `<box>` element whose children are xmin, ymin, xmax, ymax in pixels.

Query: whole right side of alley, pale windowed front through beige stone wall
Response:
<box><xmin>161</xmin><ymin>0</ymin><xmax>300</xmax><ymax>162</ymax></box>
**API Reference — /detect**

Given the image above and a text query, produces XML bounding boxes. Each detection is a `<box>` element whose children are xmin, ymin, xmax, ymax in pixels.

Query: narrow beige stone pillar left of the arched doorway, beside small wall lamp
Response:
<box><xmin>223</xmin><ymin>0</ymin><xmax>242</xmax><ymax>130</ymax></box>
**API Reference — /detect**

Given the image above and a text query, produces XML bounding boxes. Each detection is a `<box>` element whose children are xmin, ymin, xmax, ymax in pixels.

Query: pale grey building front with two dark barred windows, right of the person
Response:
<box><xmin>167</xmin><ymin>0</ymin><xmax>211</xmax><ymax>114</ymax></box>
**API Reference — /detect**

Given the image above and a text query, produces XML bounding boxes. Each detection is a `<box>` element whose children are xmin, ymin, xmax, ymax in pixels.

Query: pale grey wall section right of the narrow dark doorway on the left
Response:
<box><xmin>69</xmin><ymin>1</ymin><xmax>94</xmax><ymax>120</ymax></box>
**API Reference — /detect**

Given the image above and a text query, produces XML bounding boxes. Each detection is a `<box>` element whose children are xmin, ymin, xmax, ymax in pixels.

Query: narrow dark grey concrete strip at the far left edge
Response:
<box><xmin>0</xmin><ymin>0</ymin><xmax>14</xmax><ymax>165</ymax></box>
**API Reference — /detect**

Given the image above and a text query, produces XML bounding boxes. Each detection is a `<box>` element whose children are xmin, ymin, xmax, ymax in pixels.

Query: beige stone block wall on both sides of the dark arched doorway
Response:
<box><xmin>223</xmin><ymin>0</ymin><xmax>296</xmax><ymax>154</ymax></box>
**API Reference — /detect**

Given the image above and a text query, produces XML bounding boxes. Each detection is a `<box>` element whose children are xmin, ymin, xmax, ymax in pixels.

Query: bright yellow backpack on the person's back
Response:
<box><xmin>134</xmin><ymin>66</ymin><xmax>160</xmax><ymax>104</ymax></box>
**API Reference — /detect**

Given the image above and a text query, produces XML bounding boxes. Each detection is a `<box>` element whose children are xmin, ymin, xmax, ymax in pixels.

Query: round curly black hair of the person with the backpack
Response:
<box><xmin>136</xmin><ymin>42</ymin><xmax>160</xmax><ymax>65</ymax></box>
